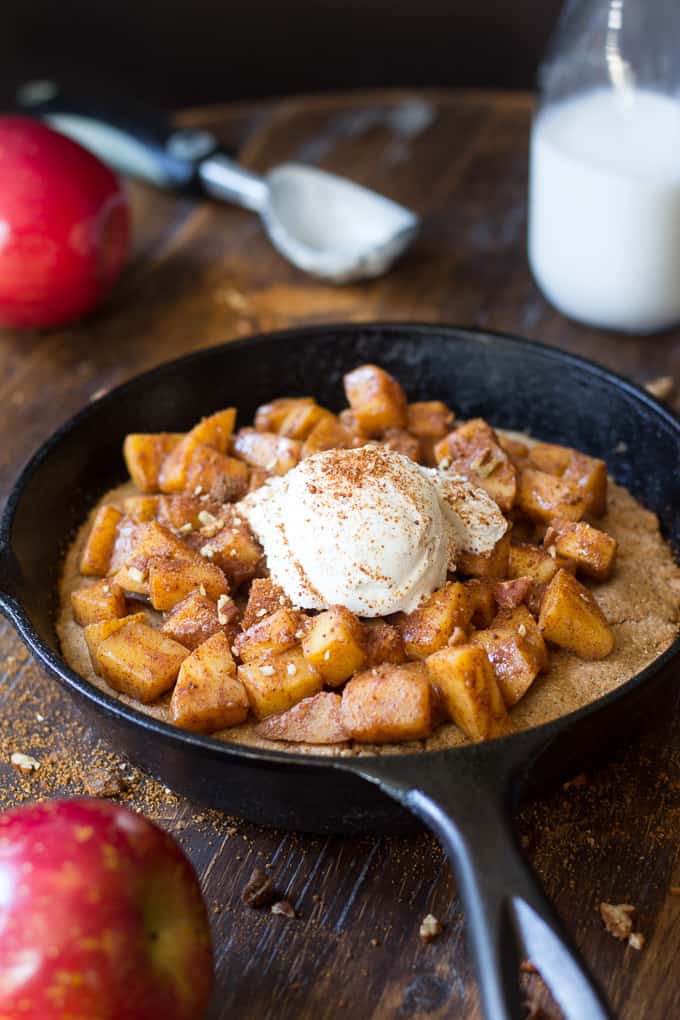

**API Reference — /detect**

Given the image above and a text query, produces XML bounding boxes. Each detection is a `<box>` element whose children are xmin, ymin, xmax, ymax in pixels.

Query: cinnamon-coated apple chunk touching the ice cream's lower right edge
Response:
<box><xmin>398</xmin><ymin>581</ymin><xmax>473</xmax><ymax>659</ymax></box>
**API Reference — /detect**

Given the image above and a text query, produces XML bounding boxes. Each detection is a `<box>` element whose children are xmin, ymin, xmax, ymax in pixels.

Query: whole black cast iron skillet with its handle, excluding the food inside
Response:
<box><xmin>0</xmin><ymin>323</ymin><xmax>680</xmax><ymax>1020</ymax></box>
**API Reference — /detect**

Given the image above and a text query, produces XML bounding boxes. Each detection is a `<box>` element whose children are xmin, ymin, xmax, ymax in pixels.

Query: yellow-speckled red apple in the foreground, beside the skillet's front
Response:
<box><xmin>0</xmin><ymin>800</ymin><xmax>213</xmax><ymax>1020</ymax></box>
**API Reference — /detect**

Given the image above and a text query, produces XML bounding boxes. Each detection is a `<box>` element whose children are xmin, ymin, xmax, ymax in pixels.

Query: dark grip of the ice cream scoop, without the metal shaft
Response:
<box><xmin>16</xmin><ymin>81</ymin><xmax>218</xmax><ymax>192</ymax></box>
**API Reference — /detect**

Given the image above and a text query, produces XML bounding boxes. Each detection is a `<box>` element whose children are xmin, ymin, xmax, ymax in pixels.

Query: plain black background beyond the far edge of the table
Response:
<box><xmin>0</xmin><ymin>0</ymin><xmax>562</xmax><ymax>108</ymax></box>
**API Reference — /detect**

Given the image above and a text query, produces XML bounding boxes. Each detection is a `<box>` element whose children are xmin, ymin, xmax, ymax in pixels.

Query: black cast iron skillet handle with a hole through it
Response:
<box><xmin>355</xmin><ymin>742</ymin><xmax>612</xmax><ymax>1020</ymax></box>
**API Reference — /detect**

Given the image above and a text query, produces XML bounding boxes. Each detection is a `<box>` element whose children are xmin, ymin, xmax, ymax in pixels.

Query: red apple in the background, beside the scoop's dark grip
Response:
<box><xmin>0</xmin><ymin>116</ymin><xmax>129</xmax><ymax>328</ymax></box>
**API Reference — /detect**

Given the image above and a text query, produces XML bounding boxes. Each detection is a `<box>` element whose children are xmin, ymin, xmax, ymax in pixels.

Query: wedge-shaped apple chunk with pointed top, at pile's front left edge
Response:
<box><xmin>170</xmin><ymin>633</ymin><xmax>249</xmax><ymax>733</ymax></box>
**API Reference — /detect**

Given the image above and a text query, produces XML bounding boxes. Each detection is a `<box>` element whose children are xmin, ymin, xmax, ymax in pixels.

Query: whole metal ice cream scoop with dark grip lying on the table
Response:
<box><xmin>17</xmin><ymin>81</ymin><xmax>418</xmax><ymax>284</ymax></box>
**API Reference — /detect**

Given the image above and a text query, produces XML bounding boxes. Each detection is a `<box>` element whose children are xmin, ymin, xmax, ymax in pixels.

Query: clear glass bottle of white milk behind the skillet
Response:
<box><xmin>528</xmin><ymin>0</ymin><xmax>680</xmax><ymax>333</ymax></box>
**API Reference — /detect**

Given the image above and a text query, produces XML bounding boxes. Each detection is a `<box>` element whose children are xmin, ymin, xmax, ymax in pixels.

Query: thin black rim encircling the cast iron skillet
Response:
<box><xmin>0</xmin><ymin>320</ymin><xmax>680</xmax><ymax>772</ymax></box>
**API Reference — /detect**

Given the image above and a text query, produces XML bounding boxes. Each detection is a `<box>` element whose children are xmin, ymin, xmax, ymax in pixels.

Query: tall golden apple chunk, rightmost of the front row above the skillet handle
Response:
<box><xmin>425</xmin><ymin>645</ymin><xmax>512</xmax><ymax>741</ymax></box>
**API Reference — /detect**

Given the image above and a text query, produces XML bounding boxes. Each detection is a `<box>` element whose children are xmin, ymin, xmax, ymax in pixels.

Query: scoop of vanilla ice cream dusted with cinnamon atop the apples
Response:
<box><xmin>239</xmin><ymin>446</ymin><xmax>508</xmax><ymax>617</ymax></box>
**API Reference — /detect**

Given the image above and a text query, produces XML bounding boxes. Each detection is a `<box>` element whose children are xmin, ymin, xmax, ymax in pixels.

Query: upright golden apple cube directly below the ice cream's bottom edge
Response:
<box><xmin>302</xmin><ymin>606</ymin><xmax>366</xmax><ymax>687</ymax></box>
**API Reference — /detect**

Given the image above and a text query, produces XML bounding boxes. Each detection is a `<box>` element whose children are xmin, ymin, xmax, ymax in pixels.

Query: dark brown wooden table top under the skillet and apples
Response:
<box><xmin>0</xmin><ymin>92</ymin><xmax>680</xmax><ymax>1020</ymax></box>
